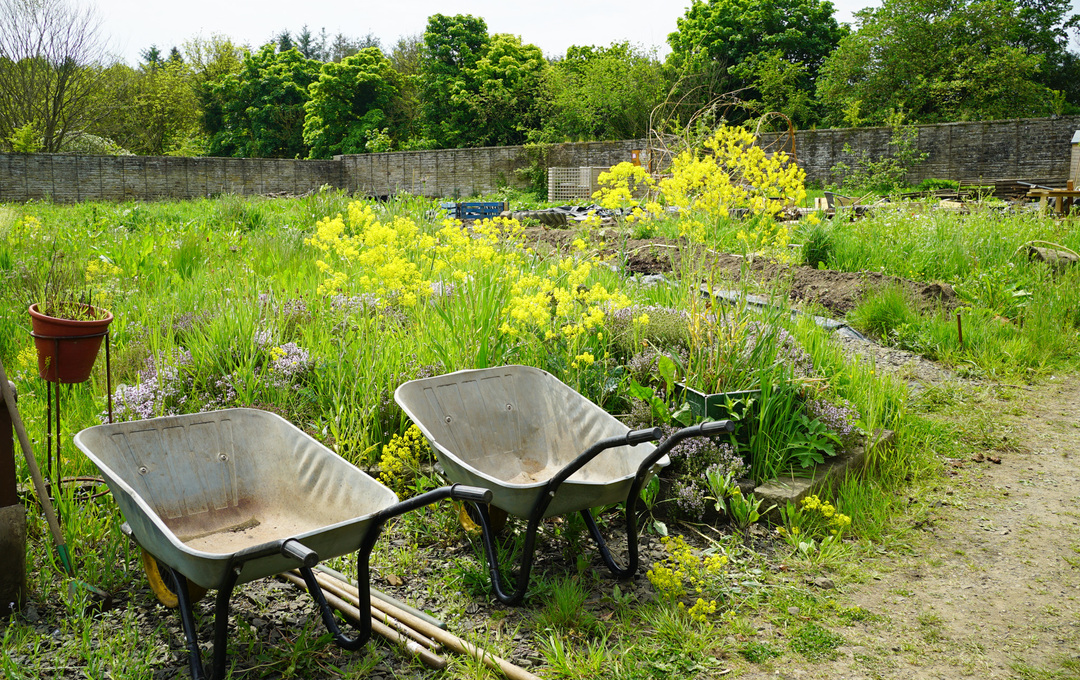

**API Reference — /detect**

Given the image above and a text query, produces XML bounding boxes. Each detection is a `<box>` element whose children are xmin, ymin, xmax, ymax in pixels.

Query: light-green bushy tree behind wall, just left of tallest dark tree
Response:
<box><xmin>540</xmin><ymin>42</ymin><xmax>669</xmax><ymax>141</ymax></box>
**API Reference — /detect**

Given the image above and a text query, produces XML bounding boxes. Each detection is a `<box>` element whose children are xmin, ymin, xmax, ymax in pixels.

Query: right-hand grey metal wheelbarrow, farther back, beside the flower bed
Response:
<box><xmin>394</xmin><ymin>366</ymin><xmax>734</xmax><ymax>604</ymax></box>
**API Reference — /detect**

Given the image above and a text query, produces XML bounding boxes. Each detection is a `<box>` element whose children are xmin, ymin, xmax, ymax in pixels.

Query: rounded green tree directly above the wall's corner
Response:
<box><xmin>303</xmin><ymin>47</ymin><xmax>397</xmax><ymax>159</ymax></box>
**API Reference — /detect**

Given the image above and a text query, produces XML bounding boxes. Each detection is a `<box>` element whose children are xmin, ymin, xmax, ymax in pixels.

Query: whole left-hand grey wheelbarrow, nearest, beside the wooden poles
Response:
<box><xmin>75</xmin><ymin>409</ymin><xmax>489</xmax><ymax>678</ymax></box>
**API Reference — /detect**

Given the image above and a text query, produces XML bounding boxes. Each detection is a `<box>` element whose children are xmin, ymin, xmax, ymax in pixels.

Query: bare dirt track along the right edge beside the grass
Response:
<box><xmin>743</xmin><ymin>377</ymin><xmax>1080</xmax><ymax>680</ymax></box>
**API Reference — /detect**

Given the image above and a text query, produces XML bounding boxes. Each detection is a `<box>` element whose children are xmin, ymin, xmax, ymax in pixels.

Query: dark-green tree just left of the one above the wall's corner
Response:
<box><xmin>205</xmin><ymin>44</ymin><xmax>321</xmax><ymax>158</ymax></box>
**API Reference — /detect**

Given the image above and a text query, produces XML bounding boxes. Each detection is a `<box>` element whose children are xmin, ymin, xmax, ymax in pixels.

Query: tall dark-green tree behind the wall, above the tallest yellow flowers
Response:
<box><xmin>667</xmin><ymin>0</ymin><xmax>847</xmax><ymax>121</ymax></box>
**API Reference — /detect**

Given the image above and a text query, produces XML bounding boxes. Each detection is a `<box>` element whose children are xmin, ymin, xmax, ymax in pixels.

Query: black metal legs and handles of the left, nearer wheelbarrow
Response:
<box><xmin>154</xmin><ymin>485</ymin><xmax>491</xmax><ymax>680</ymax></box>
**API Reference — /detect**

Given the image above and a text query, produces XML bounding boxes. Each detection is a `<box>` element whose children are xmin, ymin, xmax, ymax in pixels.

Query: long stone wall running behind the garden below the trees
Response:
<box><xmin>0</xmin><ymin>115</ymin><xmax>1080</xmax><ymax>203</ymax></box>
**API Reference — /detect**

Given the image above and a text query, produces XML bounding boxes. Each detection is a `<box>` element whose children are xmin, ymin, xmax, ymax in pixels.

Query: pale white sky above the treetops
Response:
<box><xmin>92</xmin><ymin>0</ymin><xmax>879</xmax><ymax>66</ymax></box>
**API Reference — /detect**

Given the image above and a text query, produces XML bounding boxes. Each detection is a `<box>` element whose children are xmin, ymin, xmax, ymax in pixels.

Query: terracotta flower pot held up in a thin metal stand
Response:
<box><xmin>30</xmin><ymin>304</ymin><xmax>112</xmax><ymax>383</ymax></box>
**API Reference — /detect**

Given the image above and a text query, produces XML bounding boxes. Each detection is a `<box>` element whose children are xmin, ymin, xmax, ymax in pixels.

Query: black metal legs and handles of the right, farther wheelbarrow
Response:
<box><xmin>473</xmin><ymin>420</ymin><xmax>735</xmax><ymax>604</ymax></box>
